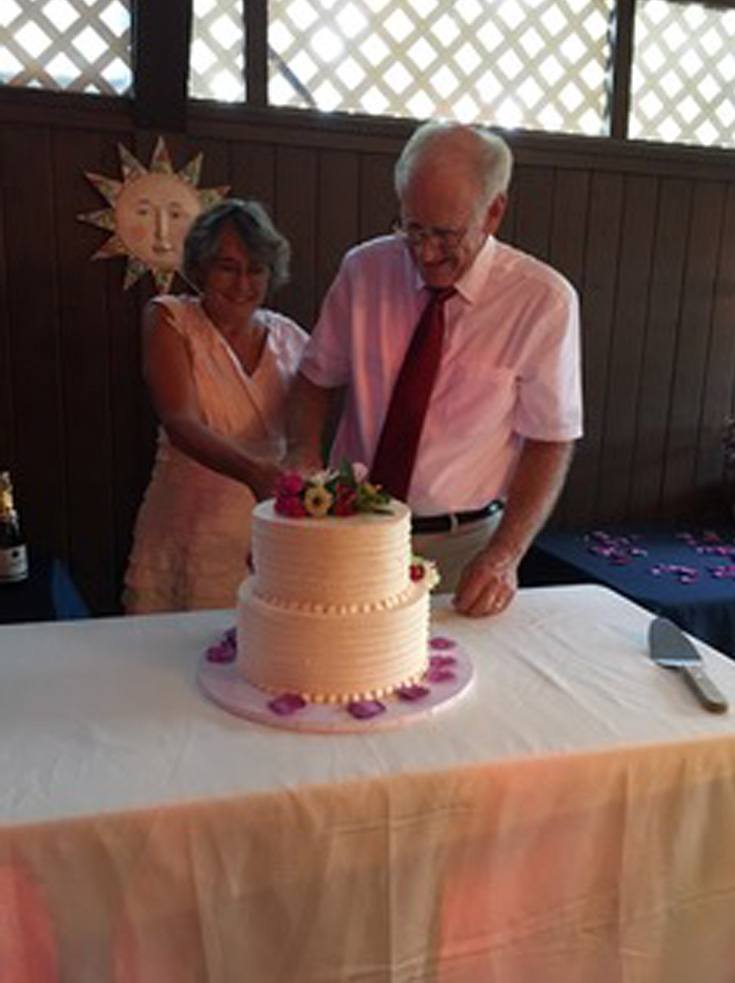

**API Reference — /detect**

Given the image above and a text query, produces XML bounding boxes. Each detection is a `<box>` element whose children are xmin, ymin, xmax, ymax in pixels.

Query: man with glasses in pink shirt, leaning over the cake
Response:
<box><xmin>289</xmin><ymin>123</ymin><xmax>581</xmax><ymax>616</ymax></box>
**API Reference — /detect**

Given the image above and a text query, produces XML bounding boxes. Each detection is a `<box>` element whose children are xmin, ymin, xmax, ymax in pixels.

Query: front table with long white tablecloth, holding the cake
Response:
<box><xmin>0</xmin><ymin>585</ymin><xmax>735</xmax><ymax>983</ymax></box>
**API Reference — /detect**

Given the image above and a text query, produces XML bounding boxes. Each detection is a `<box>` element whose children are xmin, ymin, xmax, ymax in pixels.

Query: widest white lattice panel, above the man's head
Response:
<box><xmin>269</xmin><ymin>0</ymin><xmax>612</xmax><ymax>134</ymax></box>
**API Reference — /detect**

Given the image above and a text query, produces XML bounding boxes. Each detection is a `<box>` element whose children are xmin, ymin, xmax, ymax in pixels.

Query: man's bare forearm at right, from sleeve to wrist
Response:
<box><xmin>489</xmin><ymin>440</ymin><xmax>574</xmax><ymax>559</ymax></box>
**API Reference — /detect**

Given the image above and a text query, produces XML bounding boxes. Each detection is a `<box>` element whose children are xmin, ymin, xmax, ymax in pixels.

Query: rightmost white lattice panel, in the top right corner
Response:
<box><xmin>629</xmin><ymin>0</ymin><xmax>735</xmax><ymax>147</ymax></box>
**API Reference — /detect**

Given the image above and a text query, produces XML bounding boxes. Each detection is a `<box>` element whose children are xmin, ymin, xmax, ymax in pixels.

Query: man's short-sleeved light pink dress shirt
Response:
<box><xmin>301</xmin><ymin>236</ymin><xmax>582</xmax><ymax>515</ymax></box>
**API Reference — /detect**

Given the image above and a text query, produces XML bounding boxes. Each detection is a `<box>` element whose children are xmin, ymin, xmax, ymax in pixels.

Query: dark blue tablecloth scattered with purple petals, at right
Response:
<box><xmin>521</xmin><ymin>523</ymin><xmax>735</xmax><ymax>657</ymax></box>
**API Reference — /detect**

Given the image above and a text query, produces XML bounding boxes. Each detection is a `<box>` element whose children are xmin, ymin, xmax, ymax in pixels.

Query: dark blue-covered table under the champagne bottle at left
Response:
<box><xmin>0</xmin><ymin>550</ymin><xmax>89</xmax><ymax>624</ymax></box>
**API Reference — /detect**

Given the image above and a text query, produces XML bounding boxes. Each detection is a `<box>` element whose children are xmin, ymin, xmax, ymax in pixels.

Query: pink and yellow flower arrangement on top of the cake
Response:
<box><xmin>274</xmin><ymin>461</ymin><xmax>391</xmax><ymax>519</ymax></box>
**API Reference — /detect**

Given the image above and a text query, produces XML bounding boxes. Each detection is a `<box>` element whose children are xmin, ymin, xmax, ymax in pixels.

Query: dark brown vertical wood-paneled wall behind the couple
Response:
<box><xmin>0</xmin><ymin>93</ymin><xmax>735</xmax><ymax>613</ymax></box>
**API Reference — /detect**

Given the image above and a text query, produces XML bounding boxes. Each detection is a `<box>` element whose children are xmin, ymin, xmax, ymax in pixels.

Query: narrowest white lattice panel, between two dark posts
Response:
<box><xmin>189</xmin><ymin>0</ymin><xmax>245</xmax><ymax>102</ymax></box>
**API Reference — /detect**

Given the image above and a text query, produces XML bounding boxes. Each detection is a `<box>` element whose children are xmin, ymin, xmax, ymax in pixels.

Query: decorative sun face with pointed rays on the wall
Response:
<box><xmin>77</xmin><ymin>137</ymin><xmax>229</xmax><ymax>293</ymax></box>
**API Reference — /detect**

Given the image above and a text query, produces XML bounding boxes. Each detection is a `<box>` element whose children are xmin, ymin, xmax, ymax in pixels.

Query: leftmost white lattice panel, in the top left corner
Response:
<box><xmin>0</xmin><ymin>0</ymin><xmax>131</xmax><ymax>95</ymax></box>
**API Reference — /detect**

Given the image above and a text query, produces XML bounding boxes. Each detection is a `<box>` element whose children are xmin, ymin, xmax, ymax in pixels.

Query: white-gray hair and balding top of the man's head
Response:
<box><xmin>394</xmin><ymin>121</ymin><xmax>513</xmax><ymax>204</ymax></box>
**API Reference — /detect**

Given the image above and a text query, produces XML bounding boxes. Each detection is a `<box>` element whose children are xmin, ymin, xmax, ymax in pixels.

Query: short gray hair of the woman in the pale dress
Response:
<box><xmin>183</xmin><ymin>198</ymin><xmax>291</xmax><ymax>294</ymax></box>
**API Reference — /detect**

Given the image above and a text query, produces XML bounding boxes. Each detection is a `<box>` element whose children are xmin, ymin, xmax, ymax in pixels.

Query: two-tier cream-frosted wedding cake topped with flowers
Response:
<box><xmin>237</xmin><ymin>466</ymin><xmax>433</xmax><ymax>703</ymax></box>
